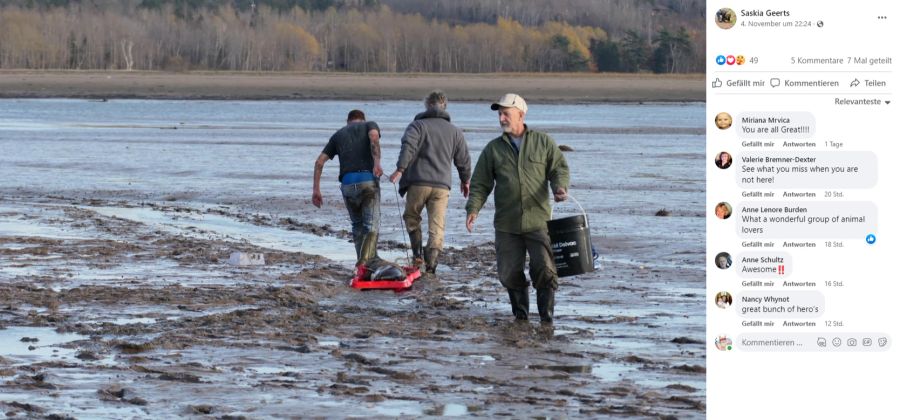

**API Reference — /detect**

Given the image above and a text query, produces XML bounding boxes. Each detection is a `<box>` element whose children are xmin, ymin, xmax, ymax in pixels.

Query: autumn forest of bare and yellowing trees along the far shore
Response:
<box><xmin>0</xmin><ymin>0</ymin><xmax>706</xmax><ymax>73</ymax></box>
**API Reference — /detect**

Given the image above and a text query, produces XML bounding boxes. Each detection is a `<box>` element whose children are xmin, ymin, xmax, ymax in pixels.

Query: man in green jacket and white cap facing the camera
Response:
<box><xmin>466</xmin><ymin>93</ymin><xmax>569</xmax><ymax>323</ymax></box>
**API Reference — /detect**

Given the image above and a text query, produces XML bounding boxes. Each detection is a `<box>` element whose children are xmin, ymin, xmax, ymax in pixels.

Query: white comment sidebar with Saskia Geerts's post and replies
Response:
<box><xmin>705</xmin><ymin>1</ymin><xmax>900</xmax><ymax>419</ymax></box>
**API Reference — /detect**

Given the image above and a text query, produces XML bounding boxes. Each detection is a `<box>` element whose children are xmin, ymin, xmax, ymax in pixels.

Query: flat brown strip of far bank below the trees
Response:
<box><xmin>0</xmin><ymin>70</ymin><xmax>705</xmax><ymax>103</ymax></box>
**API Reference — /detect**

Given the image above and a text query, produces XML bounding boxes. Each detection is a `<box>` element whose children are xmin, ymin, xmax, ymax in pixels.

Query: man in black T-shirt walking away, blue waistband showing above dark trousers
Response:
<box><xmin>312</xmin><ymin>109</ymin><xmax>382</xmax><ymax>260</ymax></box>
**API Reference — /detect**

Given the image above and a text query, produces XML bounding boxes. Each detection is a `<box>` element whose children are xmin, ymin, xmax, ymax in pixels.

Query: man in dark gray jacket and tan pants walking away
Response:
<box><xmin>391</xmin><ymin>91</ymin><xmax>472</xmax><ymax>274</ymax></box>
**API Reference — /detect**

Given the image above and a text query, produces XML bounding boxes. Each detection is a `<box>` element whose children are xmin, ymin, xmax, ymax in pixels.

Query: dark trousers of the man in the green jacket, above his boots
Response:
<box><xmin>494</xmin><ymin>230</ymin><xmax>558</xmax><ymax>290</ymax></box>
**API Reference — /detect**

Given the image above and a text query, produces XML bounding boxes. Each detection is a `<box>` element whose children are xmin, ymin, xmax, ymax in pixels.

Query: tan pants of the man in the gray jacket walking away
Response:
<box><xmin>403</xmin><ymin>185</ymin><xmax>450</xmax><ymax>249</ymax></box>
